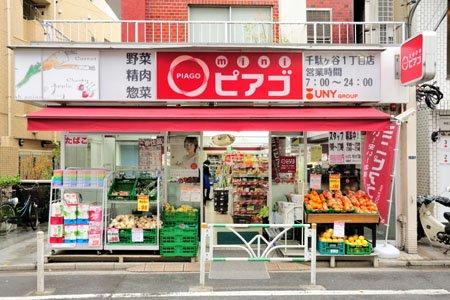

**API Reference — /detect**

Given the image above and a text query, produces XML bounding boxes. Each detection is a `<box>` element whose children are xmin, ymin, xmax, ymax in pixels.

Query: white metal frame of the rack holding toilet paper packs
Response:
<box><xmin>48</xmin><ymin>169</ymin><xmax>108</xmax><ymax>254</ymax></box>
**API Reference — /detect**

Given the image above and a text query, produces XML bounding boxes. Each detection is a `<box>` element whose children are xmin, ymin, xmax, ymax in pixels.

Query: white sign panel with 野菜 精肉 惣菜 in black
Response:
<box><xmin>100</xmin><ymin>50</ymin><xmax>156</xmax><ymax>101</ymax></box>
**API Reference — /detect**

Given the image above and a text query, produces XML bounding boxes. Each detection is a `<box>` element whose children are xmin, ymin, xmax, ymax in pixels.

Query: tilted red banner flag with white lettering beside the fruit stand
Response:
<box><xmin>362</xmin><ymin>124</ymin><xmax>398</xmax><ymax>224</ymax></box>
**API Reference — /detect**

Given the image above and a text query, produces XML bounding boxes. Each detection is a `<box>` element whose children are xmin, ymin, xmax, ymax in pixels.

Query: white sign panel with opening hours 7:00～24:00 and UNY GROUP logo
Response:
<box><xmin>303</xmin><ymin>51</ymin><xmax>381</xmax><ymax>102</ymax></box>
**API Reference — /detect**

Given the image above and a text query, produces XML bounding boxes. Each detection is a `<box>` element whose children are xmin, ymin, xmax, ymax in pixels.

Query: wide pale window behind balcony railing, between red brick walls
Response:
<box><xmin>189</xmin><ymin>6</ymin><xmax>273</xmax><ymax>43</ymax></box>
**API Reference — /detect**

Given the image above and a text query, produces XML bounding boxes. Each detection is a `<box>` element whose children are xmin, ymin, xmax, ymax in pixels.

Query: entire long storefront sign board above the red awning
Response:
<box><xmin>14</xmin><ymin>49</ymin><xmax>407</xmax><ymax>105</ymax></box>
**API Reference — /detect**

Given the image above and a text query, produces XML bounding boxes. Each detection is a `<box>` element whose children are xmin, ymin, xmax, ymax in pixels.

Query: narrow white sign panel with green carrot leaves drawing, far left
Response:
<box><xmin>15</xmin><ymin>50</ymin><xmax>42</xmax><ymax>100</ymax></box>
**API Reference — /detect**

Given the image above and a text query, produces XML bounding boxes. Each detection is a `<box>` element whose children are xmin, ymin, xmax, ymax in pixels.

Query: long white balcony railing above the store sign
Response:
<box><xmin>38</xmin><ymin>20</ymin><xmax>405</xmax><ymax>45</ymax></box>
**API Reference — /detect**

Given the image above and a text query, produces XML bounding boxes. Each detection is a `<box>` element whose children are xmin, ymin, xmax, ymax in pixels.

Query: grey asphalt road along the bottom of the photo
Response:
<box><xmin>0</xmin><ymin>268</ymin><xmax>450</xmax><ymax>300</ymax></box>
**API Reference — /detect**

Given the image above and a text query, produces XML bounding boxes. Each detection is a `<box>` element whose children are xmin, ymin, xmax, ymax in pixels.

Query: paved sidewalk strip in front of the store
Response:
<box><xmin>0</xmin><ymin>226</ymin><xmax>450</xmax><ymax>272</ymax></box>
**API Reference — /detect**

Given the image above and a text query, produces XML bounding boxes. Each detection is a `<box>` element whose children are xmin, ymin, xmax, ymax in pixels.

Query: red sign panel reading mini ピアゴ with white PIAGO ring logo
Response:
<box><xmin>157</xmin><ymin>52</ymin><xmax>302</xmax><ymax>101</ymax></box>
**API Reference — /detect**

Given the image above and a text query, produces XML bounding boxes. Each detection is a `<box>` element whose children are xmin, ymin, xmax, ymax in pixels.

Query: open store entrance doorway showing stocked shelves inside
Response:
<box><xmin>202</xmin><ymin>131</ymin><xmax>270</xmax><ymax>224</ymax></box>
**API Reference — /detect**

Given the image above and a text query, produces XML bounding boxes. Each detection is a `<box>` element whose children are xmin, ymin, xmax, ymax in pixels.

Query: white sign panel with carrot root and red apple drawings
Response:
<box><xmin>42</xmin><ymin>50</ymin><xmax>99</xmax><ymax>100</ymax></box>
